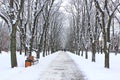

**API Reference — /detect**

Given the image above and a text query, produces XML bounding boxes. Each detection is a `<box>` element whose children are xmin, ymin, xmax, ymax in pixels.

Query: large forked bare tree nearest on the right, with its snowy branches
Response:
<box><xmin>94</xmin><ymin>0</ymin><xmax>120</xmax><ymax>68</ymax></box>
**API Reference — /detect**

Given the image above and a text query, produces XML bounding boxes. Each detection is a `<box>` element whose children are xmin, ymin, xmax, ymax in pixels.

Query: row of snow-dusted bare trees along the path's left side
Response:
<box><xmin>0</xmin><ymin>0</ymin><xmax>63</xmax><ymax>67</ymax></box>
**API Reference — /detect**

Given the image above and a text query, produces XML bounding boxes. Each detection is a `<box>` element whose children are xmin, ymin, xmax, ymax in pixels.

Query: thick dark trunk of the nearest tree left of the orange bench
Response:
<box><xmin>9</xmin><ymin>0</ymin><xmax>17</xmax><ymax>68</ymax></box>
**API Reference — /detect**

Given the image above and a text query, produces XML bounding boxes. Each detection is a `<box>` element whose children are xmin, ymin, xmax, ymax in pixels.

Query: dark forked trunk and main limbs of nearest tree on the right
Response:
<box><xmin>94</xmin><ymin>0</ymin><xmax>111</xmax><ymax>68</ymax></box>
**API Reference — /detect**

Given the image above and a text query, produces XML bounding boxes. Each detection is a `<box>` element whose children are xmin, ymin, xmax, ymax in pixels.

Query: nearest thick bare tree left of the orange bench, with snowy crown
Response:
<box><xmin>0</xmin><ymin>0</ymin><xmax>24</xmax><ymax>67</ymax></box>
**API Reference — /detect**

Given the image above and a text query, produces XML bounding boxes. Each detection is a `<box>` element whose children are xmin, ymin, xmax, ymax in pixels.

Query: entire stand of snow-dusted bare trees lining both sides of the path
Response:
<box><xmin>0</xmin><ymin>0</ymin><xmax>120</xmax><ymax>68</ymax></box>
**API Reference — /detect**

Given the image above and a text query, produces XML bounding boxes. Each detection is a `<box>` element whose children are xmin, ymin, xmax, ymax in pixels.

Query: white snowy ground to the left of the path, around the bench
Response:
<box><xmin>0</xmin><ymin>51</ymin><xmax>60</xmax><ymax>80</ymax></box>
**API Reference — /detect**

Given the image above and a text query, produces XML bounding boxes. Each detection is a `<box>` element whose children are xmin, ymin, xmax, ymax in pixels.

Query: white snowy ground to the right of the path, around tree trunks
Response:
<box><xmin>67</xmin><ymin>52</ymin><xmax>120</xmax><ymax>80</ymax></box>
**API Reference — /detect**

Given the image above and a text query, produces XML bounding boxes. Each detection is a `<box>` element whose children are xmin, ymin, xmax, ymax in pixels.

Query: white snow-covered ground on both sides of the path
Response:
<box><xmin>0</xmin><ymin>51</ymin><xmax>120</xmax><ymax>80</ymax></box>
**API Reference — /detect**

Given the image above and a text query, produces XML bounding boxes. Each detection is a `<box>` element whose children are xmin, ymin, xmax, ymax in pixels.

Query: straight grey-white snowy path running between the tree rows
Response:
<box><xmin>39</xmin><ymin>52</ymin><xmax>84</xmax><ymax>80</ymax></box>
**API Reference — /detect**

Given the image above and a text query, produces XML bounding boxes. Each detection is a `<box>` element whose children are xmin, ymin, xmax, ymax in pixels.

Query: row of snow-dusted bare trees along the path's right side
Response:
<box><xmin>66</xmin><ymin>0</ymin><xmax>120</xmax><ymax>68</ymax></box>
